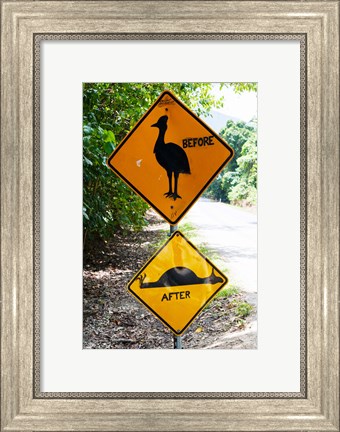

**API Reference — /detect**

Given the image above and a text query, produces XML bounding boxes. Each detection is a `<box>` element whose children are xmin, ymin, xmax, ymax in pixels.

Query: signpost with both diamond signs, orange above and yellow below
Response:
<box><xmin>107</xmin><ymin>90</ymin><xmax>234</xmax><ymax>349</ymax></box>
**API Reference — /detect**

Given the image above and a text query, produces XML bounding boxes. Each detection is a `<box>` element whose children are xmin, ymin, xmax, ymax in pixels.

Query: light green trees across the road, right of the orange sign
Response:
<box><xmin>205</xmin><ymin>118</ymin><xmax>257</xmax><ymax>205</ymax></box>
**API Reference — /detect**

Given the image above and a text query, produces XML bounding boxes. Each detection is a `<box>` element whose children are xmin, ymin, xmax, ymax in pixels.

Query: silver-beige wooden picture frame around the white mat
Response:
<box><xmin>1</xmin><ymin>0</ymin><xmax>339</xmax><ymax>431</ymax></box>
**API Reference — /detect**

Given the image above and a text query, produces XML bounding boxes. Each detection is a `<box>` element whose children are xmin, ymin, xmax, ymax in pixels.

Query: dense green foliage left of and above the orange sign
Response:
<box><xmin>83</xmin><ymin>83</ymin><xmax>221</xmax><ymax>243</ymax></box>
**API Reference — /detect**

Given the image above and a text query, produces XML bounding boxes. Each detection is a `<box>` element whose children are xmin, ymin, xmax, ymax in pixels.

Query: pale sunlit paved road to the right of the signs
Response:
<box><xmin>179</xmin><ymin>198</ymin><xmax>257</xmax><ymax>304</ymax></box>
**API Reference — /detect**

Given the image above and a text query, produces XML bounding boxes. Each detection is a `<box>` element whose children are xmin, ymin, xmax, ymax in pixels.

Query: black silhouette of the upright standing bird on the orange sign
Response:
<box><xmin>151</xmin><ymin>116</ymin><xmax>191</xmax><ymax>200</ymax></box>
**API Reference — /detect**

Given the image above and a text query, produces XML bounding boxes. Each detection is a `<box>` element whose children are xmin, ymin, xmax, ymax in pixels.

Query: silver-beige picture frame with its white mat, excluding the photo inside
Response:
<box><xmin>1</xmin><ymin>0</ymin><xmax>339</xmax><ymax>431</ymax></box>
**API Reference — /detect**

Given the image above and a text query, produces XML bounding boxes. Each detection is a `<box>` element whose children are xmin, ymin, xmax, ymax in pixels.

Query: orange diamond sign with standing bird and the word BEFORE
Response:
<box><xmin>108</xmin><ymin>90</ymin><xmax>233</xmax><ymax>225</ymax></box>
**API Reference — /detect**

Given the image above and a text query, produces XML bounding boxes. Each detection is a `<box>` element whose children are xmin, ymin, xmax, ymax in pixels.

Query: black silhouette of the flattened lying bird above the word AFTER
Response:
<box><xmin>137</xmin><ymin>267</ymin><xmax>223</xmax><ymax>288</ymax></box>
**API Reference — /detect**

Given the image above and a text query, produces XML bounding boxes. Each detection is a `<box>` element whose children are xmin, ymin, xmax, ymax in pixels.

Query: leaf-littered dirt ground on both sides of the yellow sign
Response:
<box><xmin>83</xmin><ymin>210</ymin><xmax>256</xmax><ymax>349</ymax></box>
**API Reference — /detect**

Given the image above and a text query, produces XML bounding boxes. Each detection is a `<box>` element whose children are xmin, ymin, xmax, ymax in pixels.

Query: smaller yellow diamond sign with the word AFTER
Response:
<box><xmin>128</xmin><ymin>231</ymin><xmax>228</xmax><ymax>335</ymax></box>
